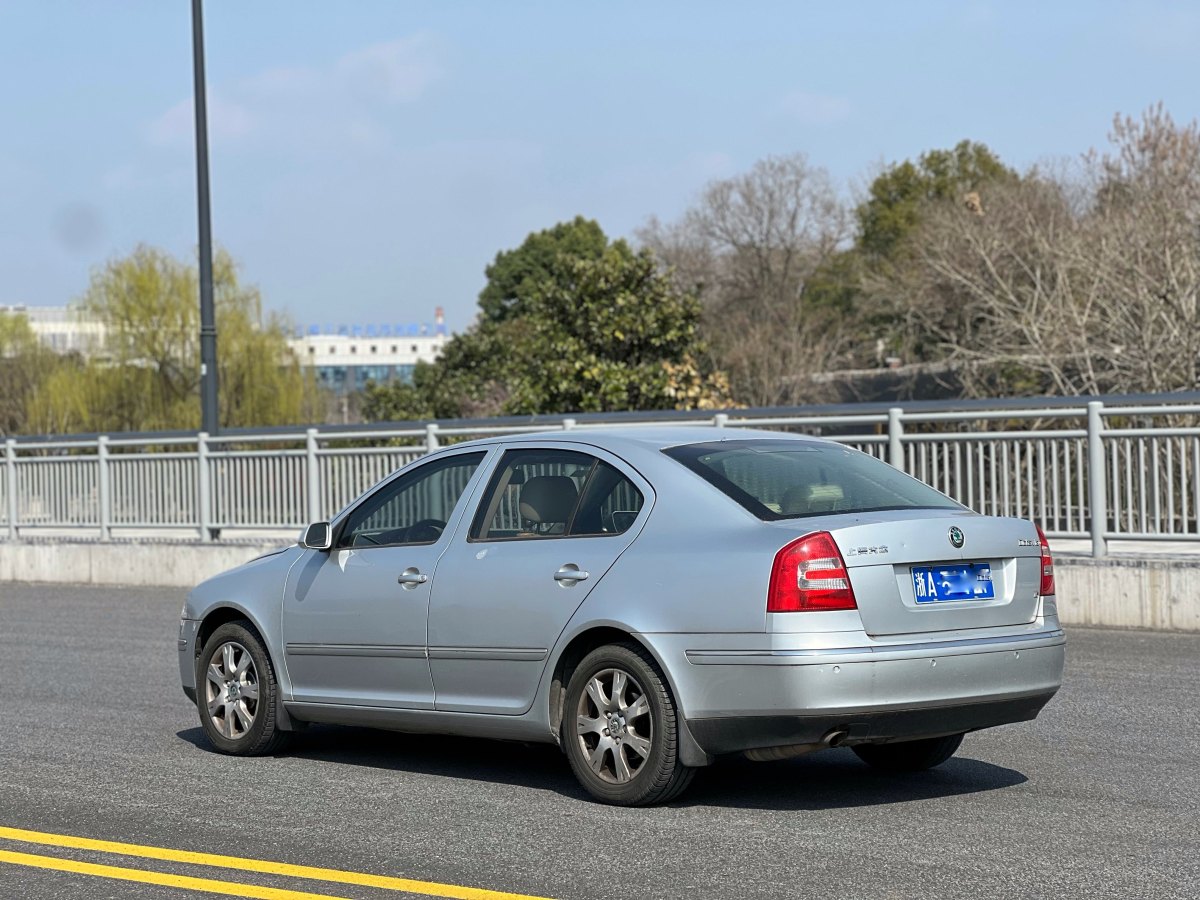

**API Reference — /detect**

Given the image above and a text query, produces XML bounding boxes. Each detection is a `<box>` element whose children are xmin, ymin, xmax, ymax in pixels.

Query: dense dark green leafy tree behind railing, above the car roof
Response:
<box><xmin>364</xmin><ymin>220</ymin><xmax>728</xmax><ymax>421</ymax></box>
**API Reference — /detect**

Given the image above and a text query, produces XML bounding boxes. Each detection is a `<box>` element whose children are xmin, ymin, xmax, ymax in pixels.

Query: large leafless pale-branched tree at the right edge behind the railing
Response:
<box><xmin>869</xmin><ymin>107</ymin><xmax>1200</xmax><ymax>395</ymax></box>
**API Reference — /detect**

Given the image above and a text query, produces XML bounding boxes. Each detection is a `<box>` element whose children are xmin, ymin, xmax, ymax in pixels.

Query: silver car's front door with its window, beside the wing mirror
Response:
<box><xmin>282</xmin><ymin>450</ymin><xmax>487</xmax><ymax>709</ymax></box>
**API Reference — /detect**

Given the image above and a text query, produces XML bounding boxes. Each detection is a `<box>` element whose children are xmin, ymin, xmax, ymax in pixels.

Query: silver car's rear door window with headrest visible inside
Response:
<box><xmin>470</xmin><ymin>450</ymin><xmax>644</xmax><ymax>541</ymax></box>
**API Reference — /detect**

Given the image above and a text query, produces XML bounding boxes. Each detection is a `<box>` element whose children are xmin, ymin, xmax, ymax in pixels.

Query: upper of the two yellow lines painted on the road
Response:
<box><xmin>0</xmin><ymin>826</ymin><xmax>546</xmax><ymax>900</ymax></box>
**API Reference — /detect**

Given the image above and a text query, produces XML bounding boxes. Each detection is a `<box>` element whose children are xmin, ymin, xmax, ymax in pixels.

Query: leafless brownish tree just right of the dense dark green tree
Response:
<box><xmin>638</xmin><ymin>155</ymin><xmax>851</xmax><ymax>406</ymax></box>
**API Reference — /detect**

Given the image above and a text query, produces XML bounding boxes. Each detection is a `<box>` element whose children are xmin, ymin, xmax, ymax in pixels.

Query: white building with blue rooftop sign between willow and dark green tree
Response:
<box><xmin>289</xmin><ymin>307</ymin><xmax>449</xmax><ymax>395</ymax></box>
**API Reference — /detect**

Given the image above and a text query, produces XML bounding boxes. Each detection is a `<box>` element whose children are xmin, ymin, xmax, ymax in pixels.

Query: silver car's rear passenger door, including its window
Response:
<box><xmin>430</xmin><ymin>445</ymin><xmax>653</xmax><ymax>715</ymax></box>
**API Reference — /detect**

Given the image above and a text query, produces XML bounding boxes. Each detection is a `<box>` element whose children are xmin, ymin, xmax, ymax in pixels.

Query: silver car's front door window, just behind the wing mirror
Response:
<box><xmin>337</xmin><ymin>452</ymin><xmax>486</xmax><ymax>547</ymax></box>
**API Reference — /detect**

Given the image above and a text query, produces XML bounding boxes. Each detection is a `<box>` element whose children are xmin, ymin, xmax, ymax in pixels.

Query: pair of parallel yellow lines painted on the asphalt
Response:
<box><xmin>0</xmin><ymin>826</ymin><xmax>545</xmax><ymax>900</ymax></box>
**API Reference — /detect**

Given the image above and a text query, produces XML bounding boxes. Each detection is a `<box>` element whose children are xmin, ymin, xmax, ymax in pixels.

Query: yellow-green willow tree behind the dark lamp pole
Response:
<box><xmin>30</xmin><ymin>246</ymin><xmax>316</xmax><ymax>431</ymax></box>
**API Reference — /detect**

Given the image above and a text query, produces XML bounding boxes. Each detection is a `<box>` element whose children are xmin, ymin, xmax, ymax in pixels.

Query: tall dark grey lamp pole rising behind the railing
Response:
<box><xmin>192</xmin><ymin>0</ymin><xmax>221</xmax><ymax>434</ymax></box>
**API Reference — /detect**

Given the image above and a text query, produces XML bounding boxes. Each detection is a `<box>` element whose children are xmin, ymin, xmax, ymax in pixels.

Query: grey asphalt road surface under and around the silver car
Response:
<box><xmin>0</xmin><ymin>583</ymin><xmax>1200</xmax><ymax>900</ymax></box>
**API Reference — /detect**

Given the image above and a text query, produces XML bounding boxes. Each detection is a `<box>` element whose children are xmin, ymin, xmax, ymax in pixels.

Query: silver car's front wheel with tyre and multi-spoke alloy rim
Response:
<box><xmin>196</xmin><ymin>620</ymin><xmax>288</xmax><ymax>756</ymax></box>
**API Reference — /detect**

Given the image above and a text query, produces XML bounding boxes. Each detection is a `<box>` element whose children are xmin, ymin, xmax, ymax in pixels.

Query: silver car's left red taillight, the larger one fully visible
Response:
<box><xmin>767</xmin><ymin>532</ymin><xmax>858</xmax><ymax>612</ymax></box>
